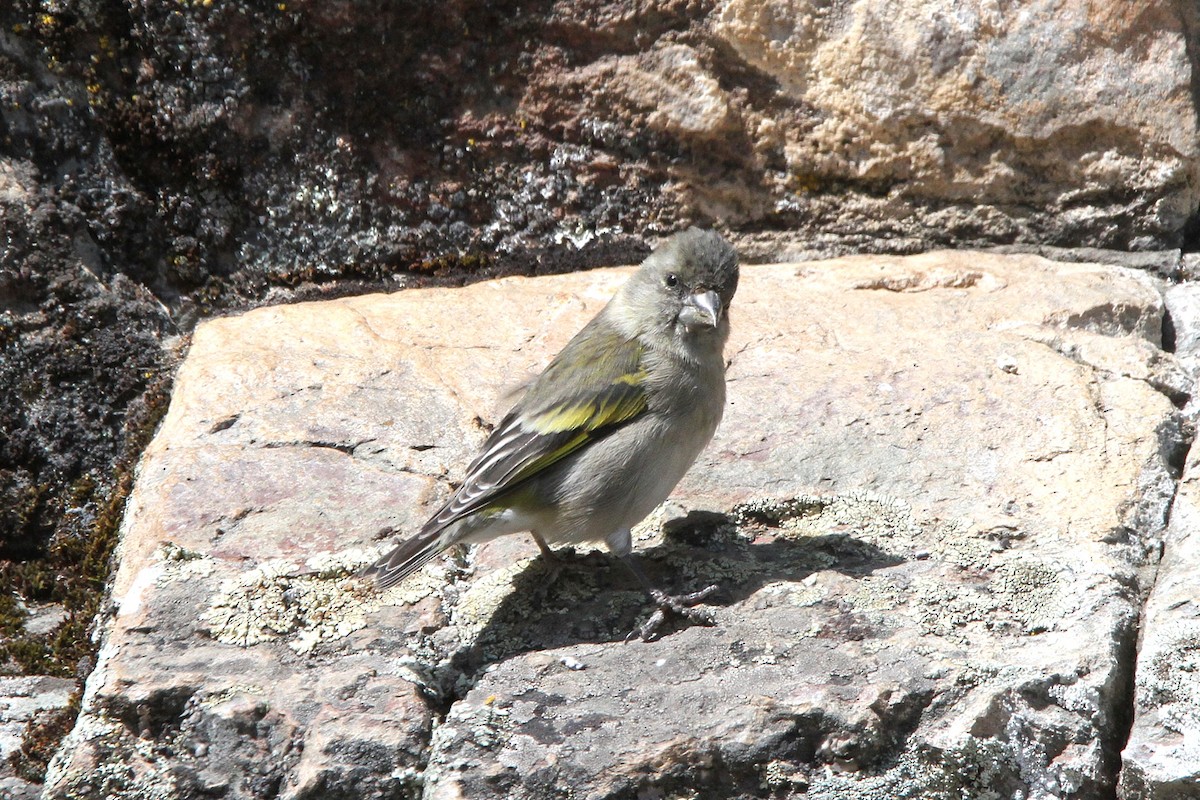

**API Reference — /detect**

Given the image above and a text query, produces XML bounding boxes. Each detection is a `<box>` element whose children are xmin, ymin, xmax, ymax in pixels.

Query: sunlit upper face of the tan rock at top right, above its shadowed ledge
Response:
<box><xmin>714</xmin><ymin>0</ymin><xmax>1195</xmax><ymax>140</ymax></box>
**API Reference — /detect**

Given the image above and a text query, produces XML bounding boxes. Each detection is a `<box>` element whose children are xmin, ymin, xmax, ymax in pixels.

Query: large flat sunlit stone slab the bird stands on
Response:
<box><xmin>47</xmin><ymin>253</ymin><xmax>1190</xmax><ymax>799</ymax></box>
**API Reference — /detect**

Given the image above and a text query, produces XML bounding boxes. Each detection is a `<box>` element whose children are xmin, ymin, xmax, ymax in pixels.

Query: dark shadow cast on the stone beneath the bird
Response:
<box><xmin>452</xmin><ymin>511</ymin><xmax>904</xmax><ymax>673</ymax></box>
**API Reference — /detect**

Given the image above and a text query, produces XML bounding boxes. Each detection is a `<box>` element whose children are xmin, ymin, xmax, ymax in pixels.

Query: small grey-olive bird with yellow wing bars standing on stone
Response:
<box><xmin>361</xmin><ymin>228</ymin><xmax>738</xmax><ymax>640</ymax></box>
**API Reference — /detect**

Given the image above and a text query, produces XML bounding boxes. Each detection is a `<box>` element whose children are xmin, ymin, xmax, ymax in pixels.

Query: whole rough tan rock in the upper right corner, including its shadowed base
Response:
<box><xmin>700</xmin><ymin>0</ymin><xmax>1200</xmax><ymax>249</ymax></box>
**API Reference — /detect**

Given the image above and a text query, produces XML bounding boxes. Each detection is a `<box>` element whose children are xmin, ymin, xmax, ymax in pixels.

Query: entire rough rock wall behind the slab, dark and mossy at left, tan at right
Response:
<box><xmin>0</xmin><ymin>0</ymin><xmax>1200</xmax><ymax>786</ymax></box>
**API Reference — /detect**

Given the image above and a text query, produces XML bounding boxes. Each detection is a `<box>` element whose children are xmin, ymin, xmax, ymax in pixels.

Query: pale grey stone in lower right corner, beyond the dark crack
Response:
<box><xmin>1117</xmin><ymin>438</ymin><xmax>1200</xmax><ymax>800</ymax></box>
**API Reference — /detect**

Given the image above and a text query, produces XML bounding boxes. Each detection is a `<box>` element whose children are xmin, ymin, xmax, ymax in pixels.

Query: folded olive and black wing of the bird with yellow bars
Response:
<box><xmin>422</xmin><ymin>320</ymin><xmax>648</xmax><ymax>534</ymax></box>
